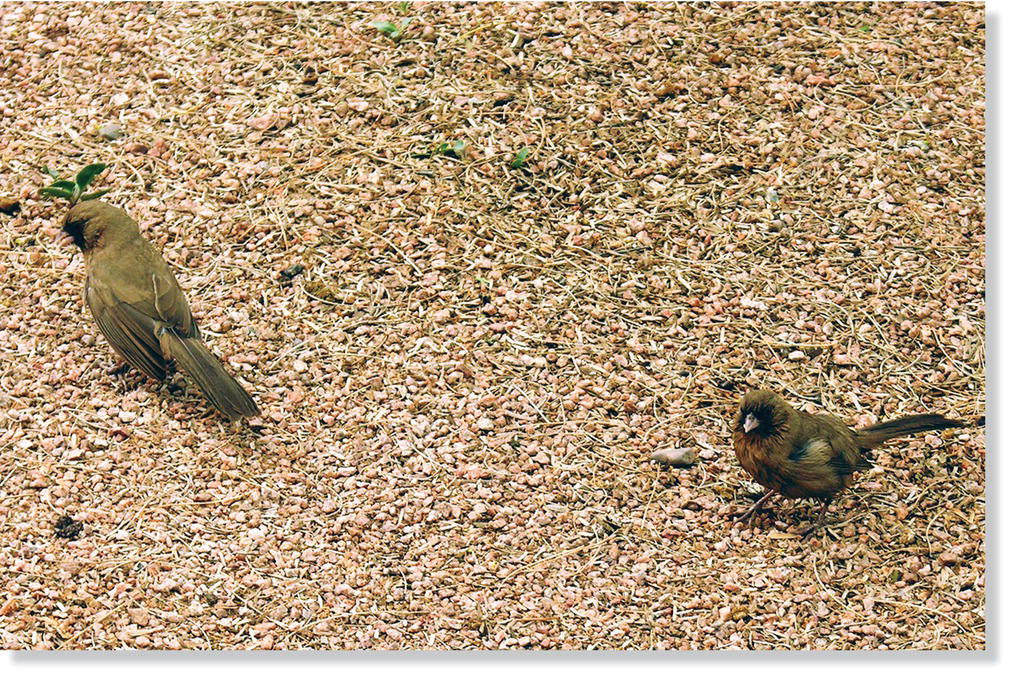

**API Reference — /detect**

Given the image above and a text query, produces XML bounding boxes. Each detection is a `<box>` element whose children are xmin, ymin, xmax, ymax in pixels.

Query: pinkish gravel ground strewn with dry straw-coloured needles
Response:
<box><xmin>0</xmin><ymin>3</ymin><xmax>985</xmax><ymax>650</ymax></box>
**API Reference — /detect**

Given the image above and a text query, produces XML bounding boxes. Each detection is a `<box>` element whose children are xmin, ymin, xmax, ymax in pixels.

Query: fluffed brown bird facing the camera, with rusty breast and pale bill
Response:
<box><xmin>732</xmin><ymin>390</ymin><xmax>964</xmax><ymax>536</ymax></box>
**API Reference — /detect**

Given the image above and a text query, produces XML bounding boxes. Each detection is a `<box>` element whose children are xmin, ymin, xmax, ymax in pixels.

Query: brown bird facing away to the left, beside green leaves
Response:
<box><xmin>63</xmin><ymin>201</ymin><xmax>260</xmax><ymax>420</ymax></box>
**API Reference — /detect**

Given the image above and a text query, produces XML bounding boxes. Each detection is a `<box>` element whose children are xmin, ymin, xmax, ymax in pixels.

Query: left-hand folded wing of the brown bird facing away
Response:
<box><xmin>84</xmin><ymin>279</ymin><xmax>165</xmax><ymax>380</ymax></box>
